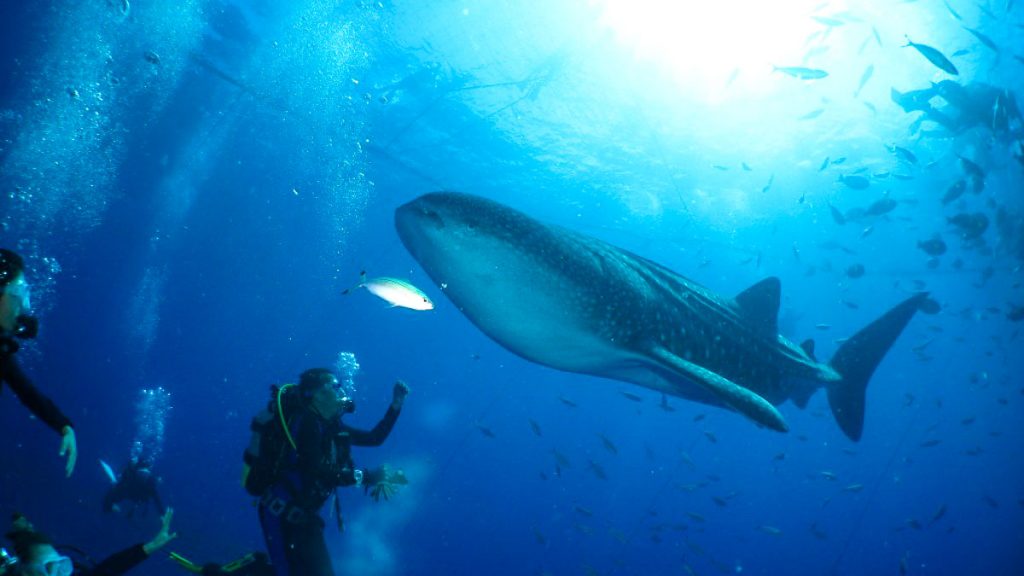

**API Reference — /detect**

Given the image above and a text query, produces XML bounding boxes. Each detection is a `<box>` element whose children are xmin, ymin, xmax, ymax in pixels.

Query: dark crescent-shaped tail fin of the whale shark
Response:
<box><xmin>828</xmin><ymin>292</ymin><xmax>928</xmax><ymax>442</ymax></box>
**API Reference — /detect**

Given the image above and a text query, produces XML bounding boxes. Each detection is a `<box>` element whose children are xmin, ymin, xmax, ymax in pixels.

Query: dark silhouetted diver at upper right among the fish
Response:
<box><xmin>890</xmin><ymin>80</ymin><xmax>1024</xmax><ymax>142</ymax></box>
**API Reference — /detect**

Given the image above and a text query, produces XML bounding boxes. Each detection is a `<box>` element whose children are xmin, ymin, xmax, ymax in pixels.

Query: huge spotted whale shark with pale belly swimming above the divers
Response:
<box><xmin>394</xmin><ymin>192</ymin><xmax>928</xmax><ymax>442</ymax></box>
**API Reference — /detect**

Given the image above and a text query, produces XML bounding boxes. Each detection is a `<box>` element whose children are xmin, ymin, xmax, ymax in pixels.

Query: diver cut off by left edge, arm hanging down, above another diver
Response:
<box><xmin>0</xmin><ymin>248</ymin><xmax>78</xmax><ymax>478</ymax></box>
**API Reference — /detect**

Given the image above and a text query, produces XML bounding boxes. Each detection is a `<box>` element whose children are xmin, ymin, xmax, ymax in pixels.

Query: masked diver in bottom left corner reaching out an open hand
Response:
<box><xmin>0</xmin><ymin>508</ymin><xmax>177</xmax><ymax>576</ymax></box>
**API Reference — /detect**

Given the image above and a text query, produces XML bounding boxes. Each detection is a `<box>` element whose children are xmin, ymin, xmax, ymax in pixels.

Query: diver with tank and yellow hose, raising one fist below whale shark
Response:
<box><xmin>242</xmin><ymin>368</ymin><xmax>409</xmax><ymax>576</ymax></box>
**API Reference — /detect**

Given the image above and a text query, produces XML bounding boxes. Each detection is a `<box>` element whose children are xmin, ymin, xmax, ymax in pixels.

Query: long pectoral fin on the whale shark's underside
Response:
<box><xmin>651</xmin><ymin>348</ymin><xmax>790</xmax><ymax>431</ymax></box>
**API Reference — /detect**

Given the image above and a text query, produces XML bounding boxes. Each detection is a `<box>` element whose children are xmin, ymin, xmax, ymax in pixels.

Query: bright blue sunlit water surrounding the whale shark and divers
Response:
<box><xmin>0</xmin><ymin>0</ymin><xmax>1024</xmax><ymax>575</ymax></box>
